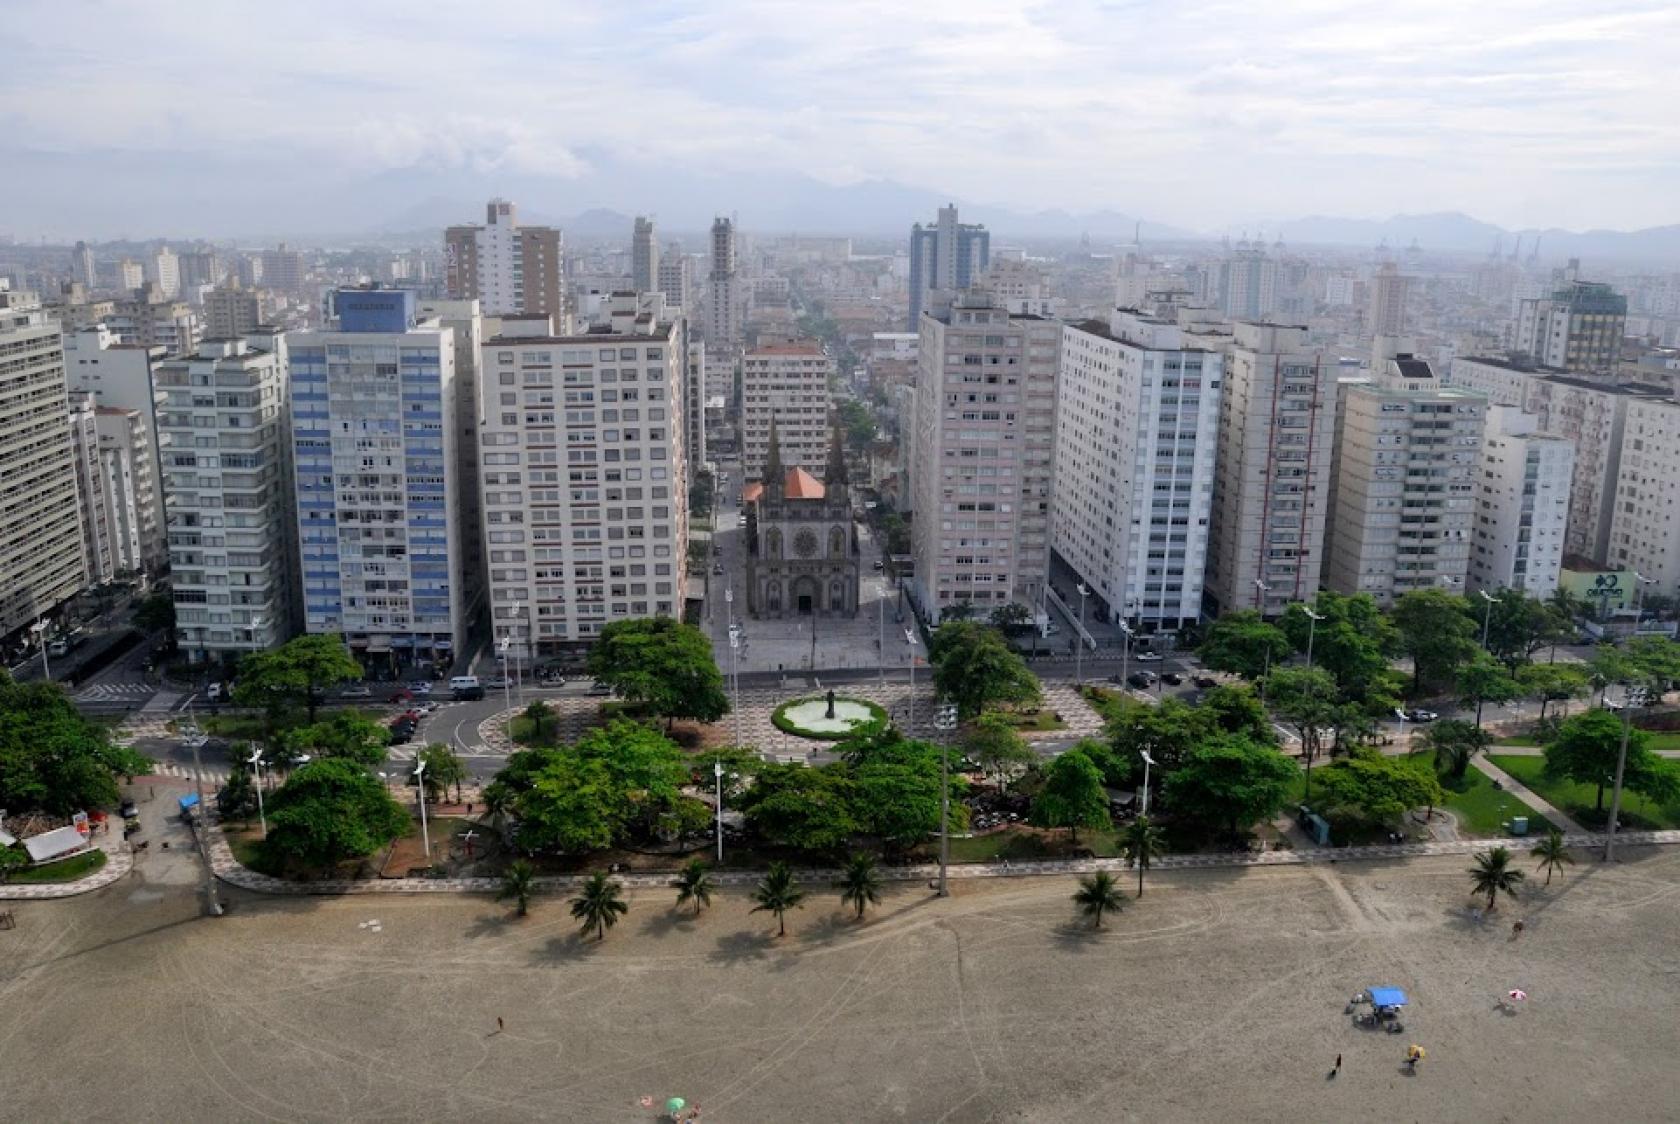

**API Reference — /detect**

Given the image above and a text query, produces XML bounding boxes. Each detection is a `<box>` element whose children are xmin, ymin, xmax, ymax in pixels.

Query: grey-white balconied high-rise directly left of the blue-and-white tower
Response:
<box><xmin>153</xmin><ymin>334</ymin><xmax>297</xmax><ymax>662</ymax></box>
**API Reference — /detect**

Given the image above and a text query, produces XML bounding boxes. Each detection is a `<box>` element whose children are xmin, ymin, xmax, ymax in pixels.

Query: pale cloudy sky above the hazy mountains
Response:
<box><xmin>0</xmin><ymin>0</ymin><xmax>1680</xmax><ymax>237</ymax></box>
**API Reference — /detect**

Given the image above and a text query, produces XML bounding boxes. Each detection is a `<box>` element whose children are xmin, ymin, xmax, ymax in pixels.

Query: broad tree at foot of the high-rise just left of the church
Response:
<box><xmin>588</xmin><ymin>617</ymin><xmax>729</xmax><ymax>722</ymax></box>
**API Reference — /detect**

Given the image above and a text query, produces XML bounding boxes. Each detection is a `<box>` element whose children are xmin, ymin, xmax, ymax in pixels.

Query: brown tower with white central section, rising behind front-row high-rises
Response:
<box><xmin>444</xmin><ymin>198</ymin><xmax>571</xmax><ymax>321</ymax></box>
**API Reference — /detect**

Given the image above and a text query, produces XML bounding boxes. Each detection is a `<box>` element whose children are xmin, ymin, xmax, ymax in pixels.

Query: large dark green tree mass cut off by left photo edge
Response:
<box><xmin>0</xmin><ymin>669</ymin><xmax>151</xmax><ymax>817</ymax></box>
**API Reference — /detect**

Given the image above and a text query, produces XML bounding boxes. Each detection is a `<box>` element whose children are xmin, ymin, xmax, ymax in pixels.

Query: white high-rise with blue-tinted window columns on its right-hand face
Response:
<box><xmin>1055</xmin><ymin>311</ymin><xmax>1225</xmax><ymax>632</ymax></box>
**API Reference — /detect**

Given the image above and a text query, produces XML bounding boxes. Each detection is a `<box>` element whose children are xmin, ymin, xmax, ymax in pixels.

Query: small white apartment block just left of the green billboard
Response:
<box><xmin>1468</xmin><ymin>407</ymin><xmax>1574</xmax><ymax>598</ymax></box>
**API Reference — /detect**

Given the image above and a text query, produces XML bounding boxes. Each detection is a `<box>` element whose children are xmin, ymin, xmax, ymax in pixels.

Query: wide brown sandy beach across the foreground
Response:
<box><xmin>0</xmin><ymin>836</ymin><xmax>1680</xmax><ymax>1122</ymax></box>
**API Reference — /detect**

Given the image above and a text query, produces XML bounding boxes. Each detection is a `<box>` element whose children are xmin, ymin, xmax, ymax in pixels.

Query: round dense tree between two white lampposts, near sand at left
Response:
<box><xmin>262</xmin><ymin>758</ymin><xmax>410</xmax><ymax>869</ymax></box>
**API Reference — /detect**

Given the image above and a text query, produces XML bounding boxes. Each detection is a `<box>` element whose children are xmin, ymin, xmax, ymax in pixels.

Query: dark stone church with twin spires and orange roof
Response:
<box><xmin>743</xmin><ymin>422</ymin><xmax>860</xmax><ymax>620</ymax></box>
